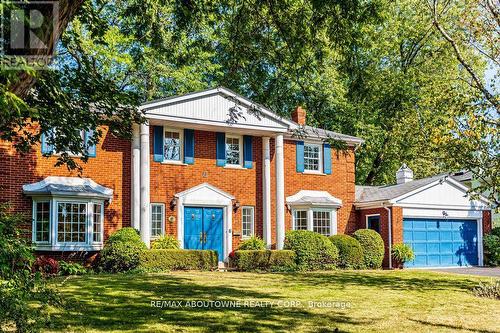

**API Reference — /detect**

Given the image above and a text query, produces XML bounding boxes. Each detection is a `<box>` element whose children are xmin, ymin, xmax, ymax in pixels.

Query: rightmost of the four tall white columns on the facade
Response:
<box><xmin>275</xmin><ymin>134</ymin><xmax>285</xmax><ymax>250</ymax></box>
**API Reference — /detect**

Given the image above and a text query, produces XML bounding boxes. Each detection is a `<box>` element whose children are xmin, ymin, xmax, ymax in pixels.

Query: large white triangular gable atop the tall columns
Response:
<box><xmin>140</xmin><ymin>88</ymin><xmax>295</xmax><ymax>132</ymax></box>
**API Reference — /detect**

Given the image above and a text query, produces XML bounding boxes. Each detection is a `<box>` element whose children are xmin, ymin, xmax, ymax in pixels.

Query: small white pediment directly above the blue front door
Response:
<box><xmin>175</xmin><ymin>183</ymin><xmax>234</xmax><ymax>206</ymax></box>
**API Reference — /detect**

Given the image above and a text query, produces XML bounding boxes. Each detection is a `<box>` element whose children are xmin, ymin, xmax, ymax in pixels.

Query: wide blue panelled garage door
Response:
<box><xmin>403</xmin><ymin>218</ymin><xmax>478</xmax><ymax>267</ymax></box>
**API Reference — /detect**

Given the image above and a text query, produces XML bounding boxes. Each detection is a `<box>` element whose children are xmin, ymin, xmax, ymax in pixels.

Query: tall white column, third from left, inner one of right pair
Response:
<box><xmin>262</xmin><ymin>137</ymin><xmax>272</xmax><ymax>249</ymax></box>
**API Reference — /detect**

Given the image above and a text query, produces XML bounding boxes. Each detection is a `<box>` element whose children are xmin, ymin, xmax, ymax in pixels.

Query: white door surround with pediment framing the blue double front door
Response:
<box><xmin>175</xmin><ymin>183</ymin><xmax>234</xmax><ymax>262</ymax></box>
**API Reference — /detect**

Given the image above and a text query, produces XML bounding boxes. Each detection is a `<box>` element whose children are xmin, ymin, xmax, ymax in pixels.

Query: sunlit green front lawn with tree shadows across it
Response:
<box><xmin>48</xmin><ymin>270</ymin><xmax>500</xmax><ymax>332</ymax></box>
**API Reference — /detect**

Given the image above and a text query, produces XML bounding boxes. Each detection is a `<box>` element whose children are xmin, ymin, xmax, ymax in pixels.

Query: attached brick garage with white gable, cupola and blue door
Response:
<box><xmin>355</xmin><ymin>165</ymin><xmax>491</xmax><ymax>268</ymax></box>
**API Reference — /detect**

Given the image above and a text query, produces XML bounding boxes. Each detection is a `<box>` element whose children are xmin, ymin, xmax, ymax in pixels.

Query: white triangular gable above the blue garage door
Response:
<box><xmin>394</xmin><ymin>179</ymin><xmax>487</xmax><ymax>210</ymax></box>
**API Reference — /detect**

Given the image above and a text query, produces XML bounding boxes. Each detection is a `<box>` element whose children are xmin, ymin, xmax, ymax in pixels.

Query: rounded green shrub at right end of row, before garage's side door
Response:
<box><xmin>353</xmin><ymin>229</ymin><xmax>385</xmax><ymax>268</ymax></box>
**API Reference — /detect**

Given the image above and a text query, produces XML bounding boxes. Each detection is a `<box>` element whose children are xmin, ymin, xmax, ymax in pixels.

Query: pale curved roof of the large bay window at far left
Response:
<box><xmin>23</xmin><ymin>176</ymin><xmax>113</xmax><ymax>201</ymax></box>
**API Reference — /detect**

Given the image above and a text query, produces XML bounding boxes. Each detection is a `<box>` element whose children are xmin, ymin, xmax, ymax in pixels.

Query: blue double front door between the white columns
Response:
<box><xmin>184</xmin><ymin>207</ymin><xmax>224</xmax><ymax>261</ymax></box>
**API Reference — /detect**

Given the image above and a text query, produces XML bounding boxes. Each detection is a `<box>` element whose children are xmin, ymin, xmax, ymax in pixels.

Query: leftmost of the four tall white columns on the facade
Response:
<box><xmin>130</xmin><ymin>124</ymin><xmax>141</xmax><ymax>230</ymax></box>
